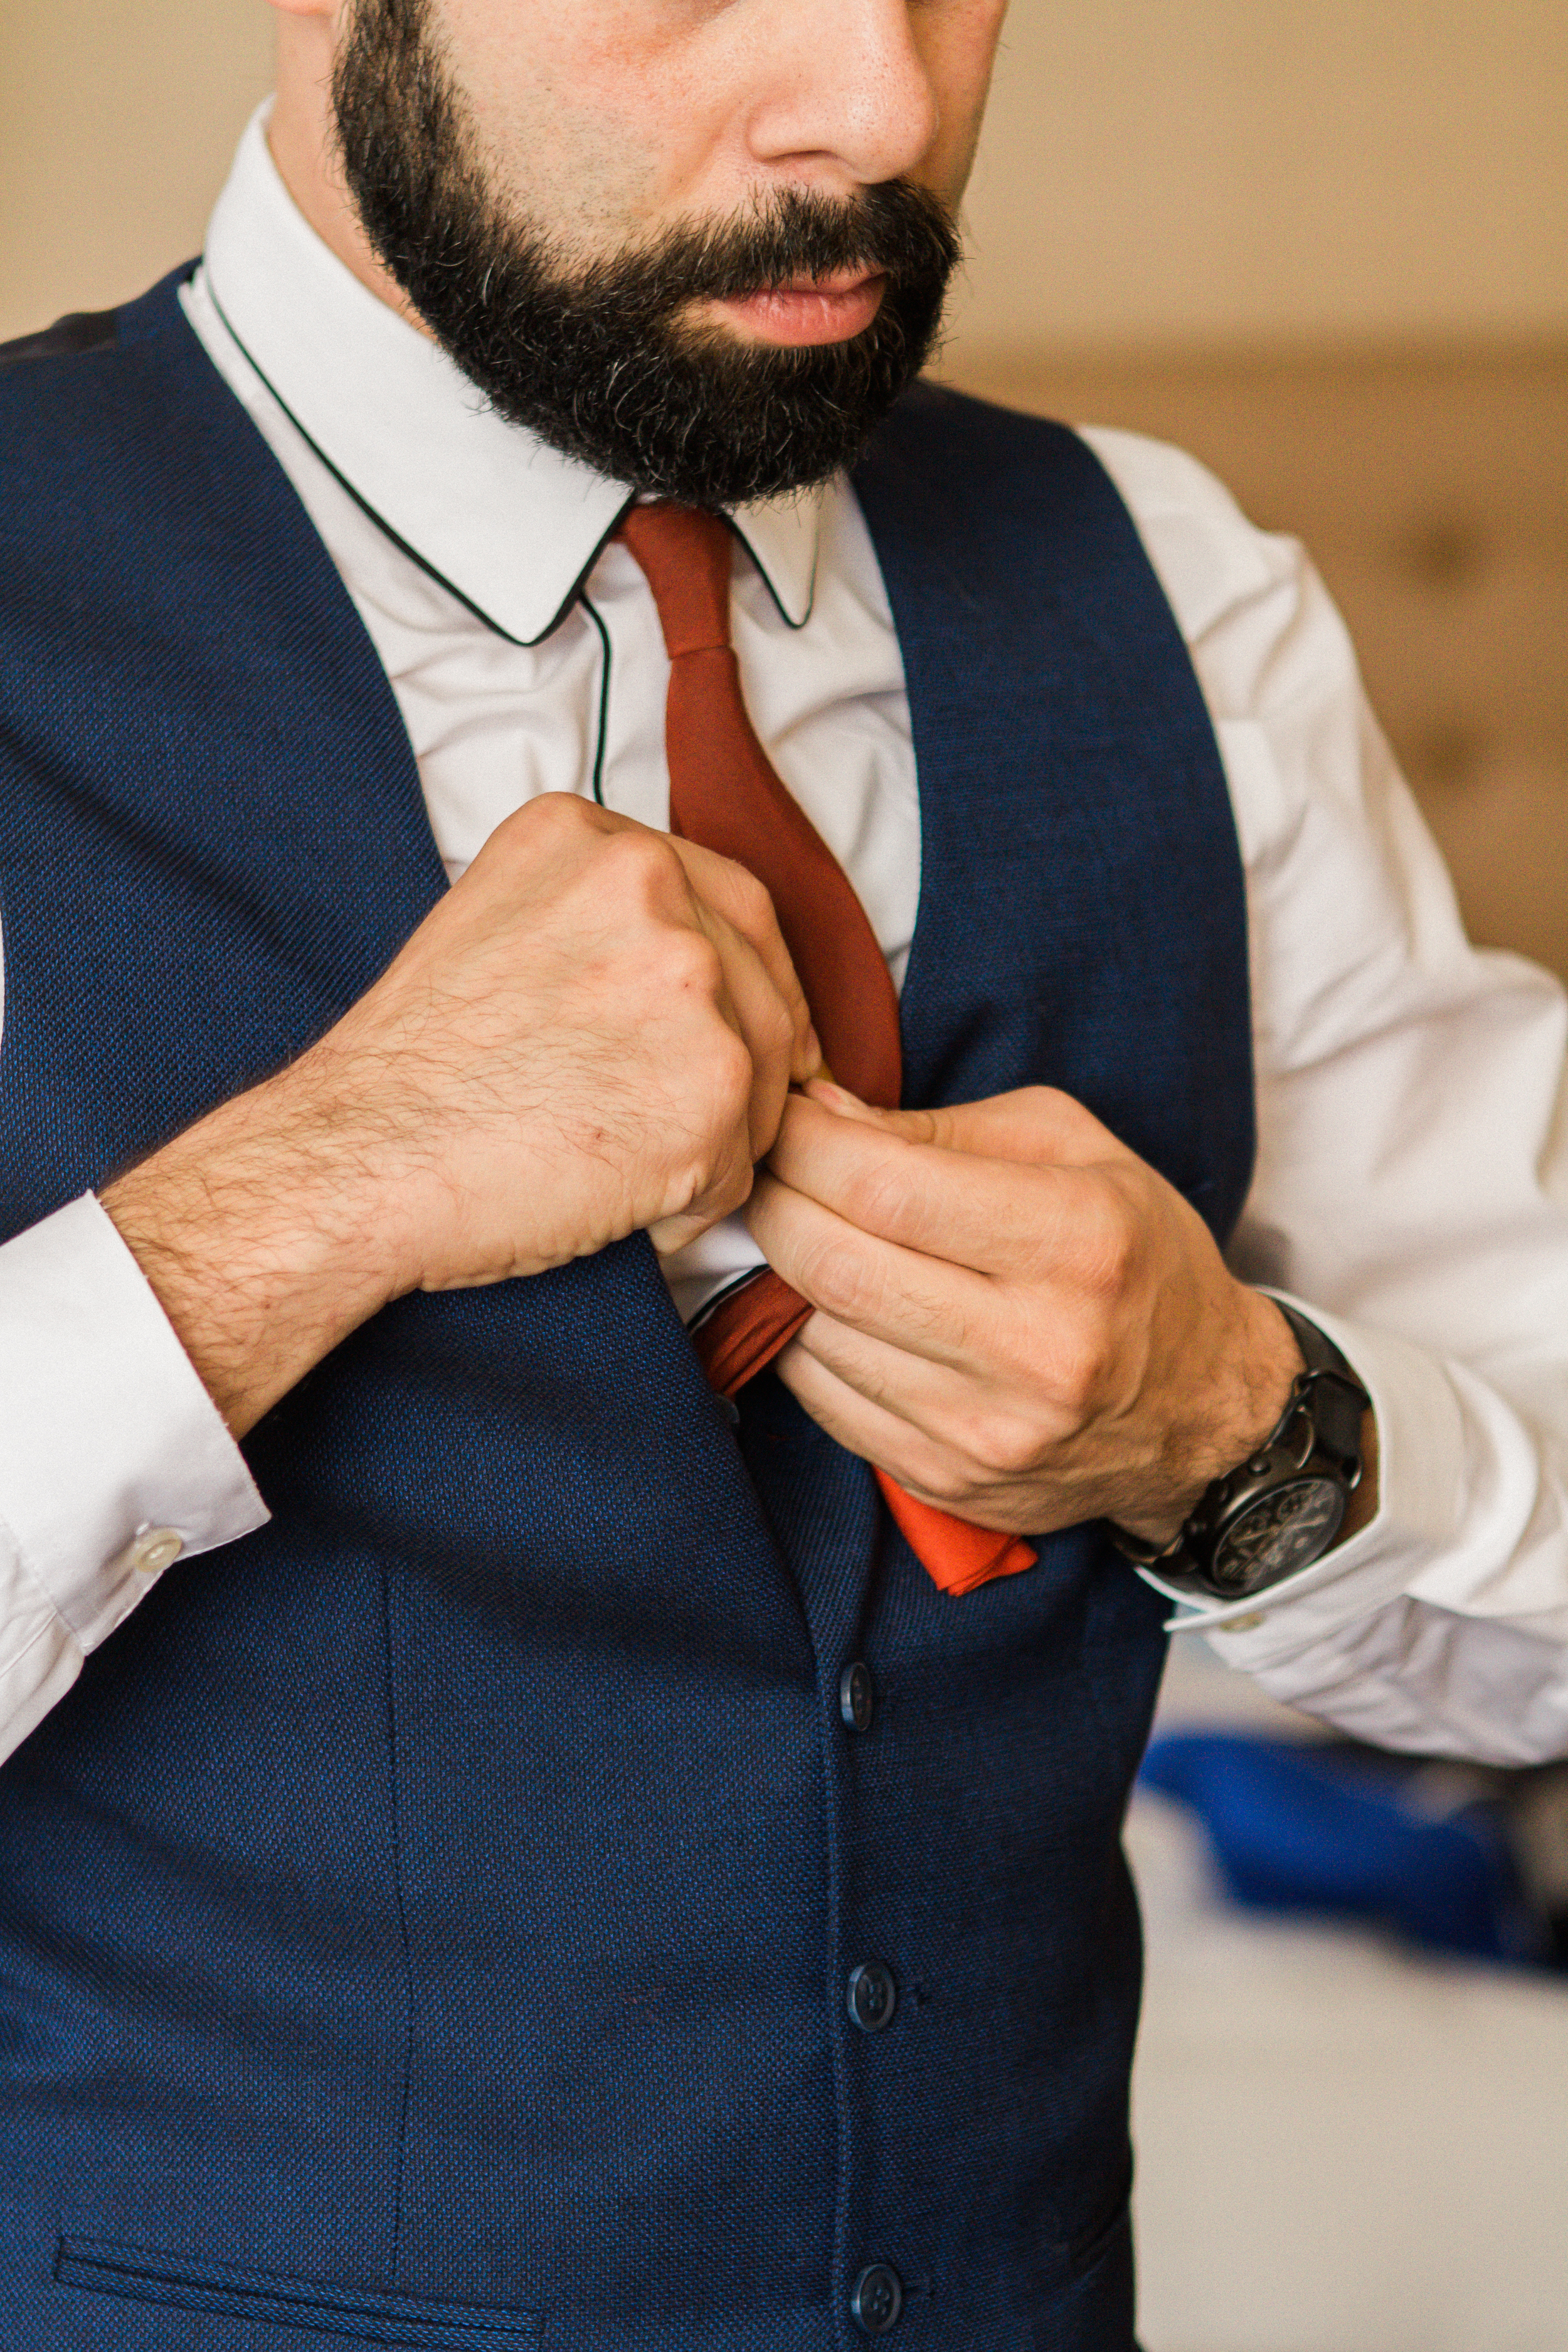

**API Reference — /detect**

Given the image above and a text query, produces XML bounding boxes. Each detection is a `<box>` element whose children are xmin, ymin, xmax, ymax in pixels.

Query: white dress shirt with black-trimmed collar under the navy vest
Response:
<box><xmin>0</xmin><ymin>109</ymin><xmax>1568</xmax><ymax>1762</ymax></box>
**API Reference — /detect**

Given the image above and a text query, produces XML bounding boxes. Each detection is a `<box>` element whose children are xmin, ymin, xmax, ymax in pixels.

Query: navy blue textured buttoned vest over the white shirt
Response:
<box><xmin>0</xmin><ymin>282</ymin><xmax>1253</xmax><ymax>2352</ymax></box>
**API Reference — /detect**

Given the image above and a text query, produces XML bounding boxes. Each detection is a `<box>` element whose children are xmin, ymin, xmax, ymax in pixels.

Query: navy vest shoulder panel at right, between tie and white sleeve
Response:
<box><xmin>856</xmin><ymin>386</ymin><xmax>1253</xmax><ymax>1232</ymax></box>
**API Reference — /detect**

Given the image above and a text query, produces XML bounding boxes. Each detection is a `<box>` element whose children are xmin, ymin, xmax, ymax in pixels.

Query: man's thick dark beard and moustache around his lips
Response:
<box><xmin>334</xmin><ymin>0</ymin><xmax>959</xmax><ymax>508</ymax></box>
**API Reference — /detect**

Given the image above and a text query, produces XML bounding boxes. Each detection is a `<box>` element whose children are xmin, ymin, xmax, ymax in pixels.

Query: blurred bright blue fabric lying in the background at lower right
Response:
<box><xmin>1140</xmin><ymin>1731</ymin><xmax>1545</xmax><ymax>1959</ymax></box>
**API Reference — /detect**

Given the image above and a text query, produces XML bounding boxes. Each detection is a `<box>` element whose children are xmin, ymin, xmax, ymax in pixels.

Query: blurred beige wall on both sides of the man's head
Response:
<box><xmin>0</xmin><ymin>0</ymin><xmax>1568</xmax><ymax>353</ymax></box>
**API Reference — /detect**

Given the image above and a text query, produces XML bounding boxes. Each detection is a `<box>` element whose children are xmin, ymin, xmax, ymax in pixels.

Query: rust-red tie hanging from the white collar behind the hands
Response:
<box><xmin>621</xmin><ymin>506</ymin><xmax>1034</xmax><ymax>1592</ymax></box>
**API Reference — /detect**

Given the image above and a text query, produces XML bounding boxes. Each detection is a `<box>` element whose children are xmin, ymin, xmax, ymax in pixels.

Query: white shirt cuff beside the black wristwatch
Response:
<box><xmin>1140</xmin><ymin>1291</ymin><xmax>1467</xmax><ymax>1670</ymax></box>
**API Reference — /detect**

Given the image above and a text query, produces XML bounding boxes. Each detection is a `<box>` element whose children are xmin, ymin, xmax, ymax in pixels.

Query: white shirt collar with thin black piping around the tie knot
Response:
<box><xmin>204</xmin><ymin>101</ymin><xmax>823</xmax><ymax>645</ymax></box>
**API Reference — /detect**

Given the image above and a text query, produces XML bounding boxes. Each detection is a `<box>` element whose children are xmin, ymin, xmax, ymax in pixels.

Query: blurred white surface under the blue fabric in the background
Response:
<box><xmin>1128</xmin><ymin>1640</ymin><xmax>1568</xmax><ymax>2352</ymax></box>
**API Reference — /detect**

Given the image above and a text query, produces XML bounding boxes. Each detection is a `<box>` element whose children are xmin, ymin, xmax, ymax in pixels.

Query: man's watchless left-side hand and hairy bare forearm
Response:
<box><xmin>103</xmin><ymin>793</ymin><xmax>820</xmax><ymax>1433</ymax></box>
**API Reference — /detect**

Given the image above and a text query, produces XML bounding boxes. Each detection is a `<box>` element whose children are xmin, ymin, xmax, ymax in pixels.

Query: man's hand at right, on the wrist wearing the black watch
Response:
<box><xmin>748</xmin><ymin>1082</ymin><xmax>1302</xmax><ymax>1545</ymax></box>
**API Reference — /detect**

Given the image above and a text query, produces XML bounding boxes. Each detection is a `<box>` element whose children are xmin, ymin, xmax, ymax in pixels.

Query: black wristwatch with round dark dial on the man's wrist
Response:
<box><xmin>1110</xmin><ymin>1298</ymin><xmax>1373</xmax><ymax>1602</ymax></box>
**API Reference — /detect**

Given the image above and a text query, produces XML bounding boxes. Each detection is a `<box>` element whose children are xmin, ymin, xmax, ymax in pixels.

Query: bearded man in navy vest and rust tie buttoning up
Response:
<box><xmin>0</xmin><ymin>0</ymin><xmax>1568</xmax><ymax>2352</ymax></box>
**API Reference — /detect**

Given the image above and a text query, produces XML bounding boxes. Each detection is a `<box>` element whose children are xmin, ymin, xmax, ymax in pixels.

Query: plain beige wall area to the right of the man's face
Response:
<box><xmin>959</xmin><ymin>0</ymin><xmax>1568</xmax><ymax>348</ymax></box>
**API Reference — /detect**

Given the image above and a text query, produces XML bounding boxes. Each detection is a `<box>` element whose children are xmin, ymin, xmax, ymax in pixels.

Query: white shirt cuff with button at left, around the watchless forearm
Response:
<box><xmin>0</xmin><ymin>1192</ymin><xmax>268</xmax><ymax>1656</ymax></box>
